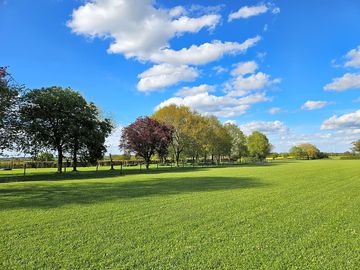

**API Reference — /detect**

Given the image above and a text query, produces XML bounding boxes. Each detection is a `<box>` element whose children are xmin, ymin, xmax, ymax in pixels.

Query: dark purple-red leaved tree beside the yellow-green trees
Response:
<box><xmin>120</xmin><ymin>117</ymin><xmax>173</xmax><ymax>169</ymax></box>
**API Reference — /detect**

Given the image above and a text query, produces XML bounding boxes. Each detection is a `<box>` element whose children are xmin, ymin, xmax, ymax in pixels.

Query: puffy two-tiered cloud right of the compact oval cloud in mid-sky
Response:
<box><xmin>226</xmin><ymin>61</ymin><xmax>280</xmax><ymax>96</ymax></box>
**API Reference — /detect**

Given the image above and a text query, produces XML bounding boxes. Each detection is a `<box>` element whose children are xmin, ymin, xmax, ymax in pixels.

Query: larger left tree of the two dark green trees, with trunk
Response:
<box><xmin>20</xmin><ymin>86</ymin><xmax>91</xmax><ymax>173</ymax></box>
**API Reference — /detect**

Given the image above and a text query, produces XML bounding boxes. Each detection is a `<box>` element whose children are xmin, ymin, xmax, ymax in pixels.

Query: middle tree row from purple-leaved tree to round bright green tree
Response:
<box><xmin>120</xmin><ymin>105</ymin><xmax>272</xmax><ymax>167</ymax></box>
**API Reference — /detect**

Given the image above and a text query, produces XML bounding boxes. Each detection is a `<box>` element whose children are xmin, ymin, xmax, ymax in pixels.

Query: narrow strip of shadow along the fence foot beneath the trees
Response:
<box><xmin>0</xmin><ymin>162</ymin><xmax>289</xmax><ymax>184</ymax></box>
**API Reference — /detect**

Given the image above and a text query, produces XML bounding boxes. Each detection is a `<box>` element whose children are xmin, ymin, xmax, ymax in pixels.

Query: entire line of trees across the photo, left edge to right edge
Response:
<box><xmin>0</xmin><ymin>67</ymin><xmax>360</xmax><ymax>173</ymax></box>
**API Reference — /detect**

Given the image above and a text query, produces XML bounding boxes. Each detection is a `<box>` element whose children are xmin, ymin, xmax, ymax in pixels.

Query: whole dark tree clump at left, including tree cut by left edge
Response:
<box><xmin>0</xmin><ymin>67</ymin><xmax>113</xmax><ymax>173</ymax></box>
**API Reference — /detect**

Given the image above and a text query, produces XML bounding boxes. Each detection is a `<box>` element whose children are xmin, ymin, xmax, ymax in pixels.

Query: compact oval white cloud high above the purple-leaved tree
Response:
<box><xmin>137</xmin><ymin>64</ymin><xmax>199</xmax><ymax>92</ymax></box>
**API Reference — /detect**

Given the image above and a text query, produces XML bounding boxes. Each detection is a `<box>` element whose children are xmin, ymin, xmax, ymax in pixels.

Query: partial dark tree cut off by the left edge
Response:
<box><xmin>0</xmin><ymin>67</ymin><xmax>23</xmax><ymax>154</ymax></box>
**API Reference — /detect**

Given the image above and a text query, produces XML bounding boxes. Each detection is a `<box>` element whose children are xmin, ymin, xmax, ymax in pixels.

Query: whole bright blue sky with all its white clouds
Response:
<box><xmin>0</xmin><ymin>0</ymin><xmax>360</xmax><ymax>153</ymax></box>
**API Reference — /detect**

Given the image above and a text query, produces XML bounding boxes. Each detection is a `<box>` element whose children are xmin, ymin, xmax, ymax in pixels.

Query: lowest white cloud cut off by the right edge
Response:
<box><xmin>321</xmin><ymin>110</ymin><xmax>360</xmax><ymax>132</ymax></box>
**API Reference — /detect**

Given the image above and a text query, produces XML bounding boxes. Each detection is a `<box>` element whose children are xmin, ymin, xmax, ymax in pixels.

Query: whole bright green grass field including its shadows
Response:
<box><xmin>0</xmin><ymin>160</ymin><xmax>360</xmax><ymax>269</ymax></box>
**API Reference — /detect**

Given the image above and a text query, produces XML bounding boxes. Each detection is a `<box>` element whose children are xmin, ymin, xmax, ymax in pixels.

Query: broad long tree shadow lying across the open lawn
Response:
<box><xmin>0</xmin><ymin>177</ymin><xmax>266</xmax><ymax>210</ymax></box>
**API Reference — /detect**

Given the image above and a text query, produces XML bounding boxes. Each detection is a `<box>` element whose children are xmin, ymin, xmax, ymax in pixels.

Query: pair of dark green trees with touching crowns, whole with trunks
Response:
<box><xmin>20</xmin><ymin>87</ymin><xmax>112</xmax><ymax>173</ymax></box>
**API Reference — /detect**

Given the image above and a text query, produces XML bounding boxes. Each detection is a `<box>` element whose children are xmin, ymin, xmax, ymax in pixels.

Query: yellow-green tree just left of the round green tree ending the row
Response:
<box><xmin>224</xmin><ymin>123</ymin><xmax>248</xmax><ymax>160</ymax></box>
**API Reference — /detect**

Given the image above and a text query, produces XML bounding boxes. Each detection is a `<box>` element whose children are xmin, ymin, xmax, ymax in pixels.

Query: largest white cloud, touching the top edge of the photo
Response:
<box><xmin>67</xmin><ymin>0</ymin><xmax>221</xmax><ymax>60</ymax></box>
